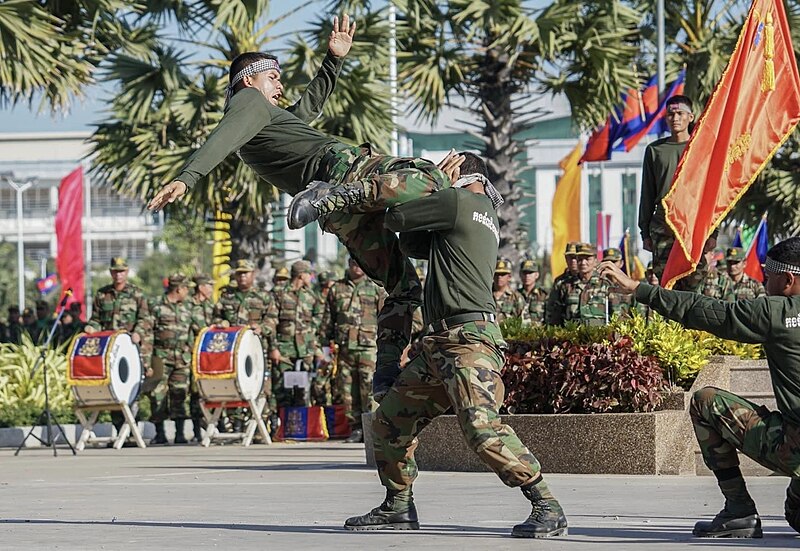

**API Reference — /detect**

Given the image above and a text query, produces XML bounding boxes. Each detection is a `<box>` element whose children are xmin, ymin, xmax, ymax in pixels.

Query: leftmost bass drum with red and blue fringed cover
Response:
<box><xmin>67</xmin><ymin>331</ymin><xmax>144</xmax><ymax>406</ymax></box>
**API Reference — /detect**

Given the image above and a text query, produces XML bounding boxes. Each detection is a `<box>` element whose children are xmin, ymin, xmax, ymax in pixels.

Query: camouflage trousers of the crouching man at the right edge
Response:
<box><xmin>689</xmin><ymin>386</ymin><xmax>800</xmax><ymax>478</ymax></box>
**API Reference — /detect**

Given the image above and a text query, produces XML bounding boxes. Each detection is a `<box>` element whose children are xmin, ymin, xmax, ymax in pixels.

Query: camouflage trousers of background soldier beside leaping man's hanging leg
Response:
<box><xmin>334</xmin><ymin>347</ymin><xmax>376</xmax><ymax>429</ymax></box>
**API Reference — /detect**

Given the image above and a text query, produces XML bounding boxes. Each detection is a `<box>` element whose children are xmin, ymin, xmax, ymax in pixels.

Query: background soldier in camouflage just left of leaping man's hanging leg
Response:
<box><xmin>320</xmin><ymin>258</ymin><xmax>386</xmax><ymax>443</ymax></box>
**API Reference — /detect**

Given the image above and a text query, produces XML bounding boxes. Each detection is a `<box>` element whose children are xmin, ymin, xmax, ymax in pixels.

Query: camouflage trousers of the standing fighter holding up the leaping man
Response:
<box><xmin>372</xmin><ymin>321</ymin><xmax>541</xmax><ymax>491</ymax></box>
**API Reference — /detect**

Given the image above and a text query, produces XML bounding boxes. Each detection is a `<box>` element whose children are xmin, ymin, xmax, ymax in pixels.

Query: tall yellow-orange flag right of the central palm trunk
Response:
<box><xmin>550</xmin><ymin>142</ymin><xmax>583</xmax><ymax>278</ymax></box>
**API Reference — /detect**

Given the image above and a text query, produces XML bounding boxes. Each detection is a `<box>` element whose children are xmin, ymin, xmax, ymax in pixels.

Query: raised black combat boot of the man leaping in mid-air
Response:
<box><xmin>286</xmin><ymin>180</ymin><xmax>366</xmax><ymax>230</ymax></box>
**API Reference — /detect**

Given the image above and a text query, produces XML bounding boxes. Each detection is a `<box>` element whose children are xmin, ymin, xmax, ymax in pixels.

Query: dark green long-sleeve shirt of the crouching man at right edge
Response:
<box><xmin>636</xmin><ymin>283</ymin><xmax>800</xmax><ymax>425</ymax></box>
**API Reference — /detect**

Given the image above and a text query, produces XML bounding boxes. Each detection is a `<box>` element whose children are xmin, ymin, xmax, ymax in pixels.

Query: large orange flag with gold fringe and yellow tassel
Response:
<box><xmin>661</xmin><ymin>0</ymin><xmax>800</xmax><ymax>288</ymax></box>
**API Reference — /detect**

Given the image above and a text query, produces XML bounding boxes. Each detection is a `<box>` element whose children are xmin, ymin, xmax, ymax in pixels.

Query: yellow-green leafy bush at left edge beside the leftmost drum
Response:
<box><xmin>0</xmin><ymin>335</ymin><xmax>74</xmax><ymax>427</ymax></box>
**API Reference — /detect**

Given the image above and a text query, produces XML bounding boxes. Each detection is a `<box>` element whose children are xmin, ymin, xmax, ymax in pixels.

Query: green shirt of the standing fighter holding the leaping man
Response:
<box><xmin>385</xmin><ymin>188</ymin><xmax>500</xmax><ymax>324</ymax></box>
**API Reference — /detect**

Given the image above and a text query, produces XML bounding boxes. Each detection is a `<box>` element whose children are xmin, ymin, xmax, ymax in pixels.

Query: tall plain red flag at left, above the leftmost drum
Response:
<box><xmin>56</xmin><ymin>167</ymin><xmax>86</xmax><ymax>304</ymax></box>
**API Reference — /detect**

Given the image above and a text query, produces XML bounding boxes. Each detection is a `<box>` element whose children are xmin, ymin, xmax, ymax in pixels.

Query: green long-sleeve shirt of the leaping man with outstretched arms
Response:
<box><xmin>177</xmin><ymin>52</ymin><xmax>343</xmax><ymax>195</ymax></box>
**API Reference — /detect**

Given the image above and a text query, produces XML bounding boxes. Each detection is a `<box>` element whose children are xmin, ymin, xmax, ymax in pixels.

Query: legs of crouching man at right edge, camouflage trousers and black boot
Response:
<box><xmin>689</xmin><ymin>387</ymin><xmax>800</xmax><ymax>538</ymax></box>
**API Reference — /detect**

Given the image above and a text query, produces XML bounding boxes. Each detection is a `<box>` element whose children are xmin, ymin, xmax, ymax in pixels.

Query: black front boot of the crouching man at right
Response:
<box><xmin>692</xmin><ymin>476</ymin><xmax>764</xmax><ymax>538</ymax></box>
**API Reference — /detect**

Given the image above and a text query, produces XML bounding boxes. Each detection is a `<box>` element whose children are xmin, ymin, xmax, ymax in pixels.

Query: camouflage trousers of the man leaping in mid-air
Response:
<box><xmin>318</xmin><ymin>145</ymin><xmax>451</xmax><ymax>376</ymax></box>
